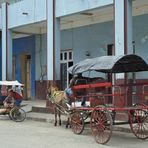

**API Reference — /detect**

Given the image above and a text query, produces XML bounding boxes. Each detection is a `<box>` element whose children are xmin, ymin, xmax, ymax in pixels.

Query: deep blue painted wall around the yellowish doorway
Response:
<box><xmin>13</xmin><ymin>36</ymin><xmax>35</xmax><ymax>98</ymax></box>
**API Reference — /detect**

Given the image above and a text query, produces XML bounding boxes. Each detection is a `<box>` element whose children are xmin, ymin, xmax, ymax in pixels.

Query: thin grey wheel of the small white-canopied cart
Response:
<box><xmin>9</xmin><ymin>108</ymin><xmax>26</xmax><ymax>122</ymax></box>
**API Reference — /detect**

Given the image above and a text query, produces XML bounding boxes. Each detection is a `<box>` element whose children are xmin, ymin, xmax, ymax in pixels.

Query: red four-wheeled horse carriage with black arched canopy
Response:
<box><xmin>48</xmin><ymin>54</ymin><xmax>148</xmax><ymax>144</ymax></box>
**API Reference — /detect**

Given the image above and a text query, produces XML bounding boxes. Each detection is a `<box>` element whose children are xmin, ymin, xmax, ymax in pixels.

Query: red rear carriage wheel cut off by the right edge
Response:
<box><xmin>128</xmin><ymin>109</ymin><xmax>148</xmax><ymax>140</ymax></box>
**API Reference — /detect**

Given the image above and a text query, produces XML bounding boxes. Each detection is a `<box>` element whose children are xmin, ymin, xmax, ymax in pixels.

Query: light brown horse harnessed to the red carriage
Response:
<box><xmin>48</xmin><ymin>85</ymin><xmax>69</xmax><ymax>128</ymax></box>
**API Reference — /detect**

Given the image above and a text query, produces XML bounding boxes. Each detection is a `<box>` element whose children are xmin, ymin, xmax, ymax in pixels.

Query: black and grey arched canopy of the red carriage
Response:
<box><xmin>68</xmin><ymin>54</ymin><xmax>148</xmax><ymax>75</ymax></box>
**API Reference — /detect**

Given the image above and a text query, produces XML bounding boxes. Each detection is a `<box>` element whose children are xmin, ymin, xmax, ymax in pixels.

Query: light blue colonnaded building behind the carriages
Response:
<box><xmin>0</xmin><ymin>0</ymin><xmax>148</xmax><ymax>104</ymax></box>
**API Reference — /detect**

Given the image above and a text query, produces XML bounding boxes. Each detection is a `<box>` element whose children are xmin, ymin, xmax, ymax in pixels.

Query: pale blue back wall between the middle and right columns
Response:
<box><xmin>61</xmin><ymin>21</ymin><xmax>114</xmax><ymax>77</ymax></box>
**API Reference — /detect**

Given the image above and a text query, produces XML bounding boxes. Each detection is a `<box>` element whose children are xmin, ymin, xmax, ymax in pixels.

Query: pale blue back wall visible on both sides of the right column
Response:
<box><xmin>61</xmin><ymin>15</ymin><xmax>148</xmax><ymax>78</ymax></box>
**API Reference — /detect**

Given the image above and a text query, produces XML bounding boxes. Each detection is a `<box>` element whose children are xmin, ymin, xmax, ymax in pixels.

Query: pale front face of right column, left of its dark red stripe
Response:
<box><xmin>114</xmin><ymin>0</ymin><xmax>124</xmax><ymax>55</ymax></box>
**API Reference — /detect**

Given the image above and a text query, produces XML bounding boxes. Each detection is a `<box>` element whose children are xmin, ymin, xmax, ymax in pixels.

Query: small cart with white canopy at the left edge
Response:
<box><xmin>0</xmin><ymin>81</ymin><xmax>26</xmax><ymax>122</ymax></box>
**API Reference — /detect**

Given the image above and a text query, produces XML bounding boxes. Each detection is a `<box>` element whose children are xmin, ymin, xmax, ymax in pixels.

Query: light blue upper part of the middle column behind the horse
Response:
<box><xmin>47</xmin><ymin>1</ymin><xmax>60</xmax><ymax>80</ymax></box>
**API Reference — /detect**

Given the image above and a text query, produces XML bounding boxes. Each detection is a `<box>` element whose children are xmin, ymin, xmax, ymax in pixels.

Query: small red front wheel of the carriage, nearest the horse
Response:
<box><xmin>71</xmin><ymin>112</ymin><xmax>84</xmax><ymax>134</ymax></box>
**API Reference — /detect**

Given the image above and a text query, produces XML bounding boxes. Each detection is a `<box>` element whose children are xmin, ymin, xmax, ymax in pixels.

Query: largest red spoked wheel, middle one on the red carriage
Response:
<box><xmin>90</xmin><ymin>109</ymin><xmax>113</xmax><ymax>144</ymax></box>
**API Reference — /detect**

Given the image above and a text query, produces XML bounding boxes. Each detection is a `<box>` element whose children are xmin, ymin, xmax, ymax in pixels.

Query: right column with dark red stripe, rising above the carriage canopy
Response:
<box><xmin>114</xmin><ymin>0</ymin><xmax>133</xmax><ymax>55</ymax></box>
